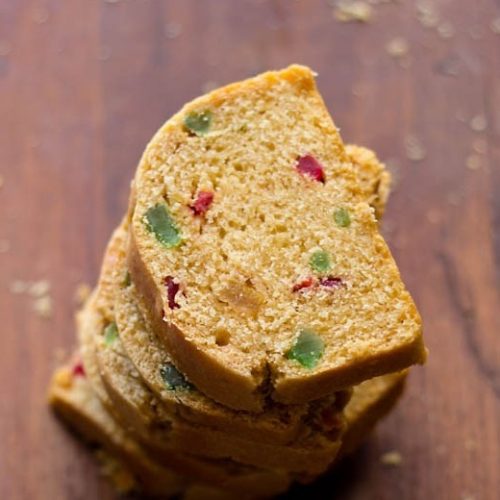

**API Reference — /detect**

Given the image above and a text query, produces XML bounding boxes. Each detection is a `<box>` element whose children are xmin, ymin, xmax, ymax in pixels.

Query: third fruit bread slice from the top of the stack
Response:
<box><xmin>78</xmin><ymin>294</ymin><xmax>300</xmax><ymax>488</ymax></box>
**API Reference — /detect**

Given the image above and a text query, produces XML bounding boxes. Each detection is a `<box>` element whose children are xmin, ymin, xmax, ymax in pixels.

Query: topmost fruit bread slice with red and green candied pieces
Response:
<box><xmin>128</xmin><ymin>66</ymin><xmax>426</xmax><ymax>412</ymax></box>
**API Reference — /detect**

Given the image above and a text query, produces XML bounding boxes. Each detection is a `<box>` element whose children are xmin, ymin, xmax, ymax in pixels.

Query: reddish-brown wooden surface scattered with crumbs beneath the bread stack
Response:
<box><xmin>0</xmin><ymin>0</ymin><xmax>500</xmax><ymax>500</ymax></box>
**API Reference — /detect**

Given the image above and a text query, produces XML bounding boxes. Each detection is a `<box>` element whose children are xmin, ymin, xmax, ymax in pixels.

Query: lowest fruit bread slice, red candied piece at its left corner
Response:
<box><xmin>49</xmin><ymin>361</ymin><xmax>290</xmax><ymax>498</ymax></box>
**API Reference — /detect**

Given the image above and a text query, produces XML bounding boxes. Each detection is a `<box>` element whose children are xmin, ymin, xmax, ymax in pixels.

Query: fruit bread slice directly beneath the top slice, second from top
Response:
<box><xmin>116</xmin><ymin>142</ymin><xmax>390</xmax><ymax>444</ymax></box>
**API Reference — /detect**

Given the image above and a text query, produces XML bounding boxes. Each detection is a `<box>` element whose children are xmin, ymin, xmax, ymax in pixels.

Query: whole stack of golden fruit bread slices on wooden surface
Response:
<box><xmin>49</xmin><ymin>66</ymin><xmax>426</xmax><ymax>498</ymax></box>
